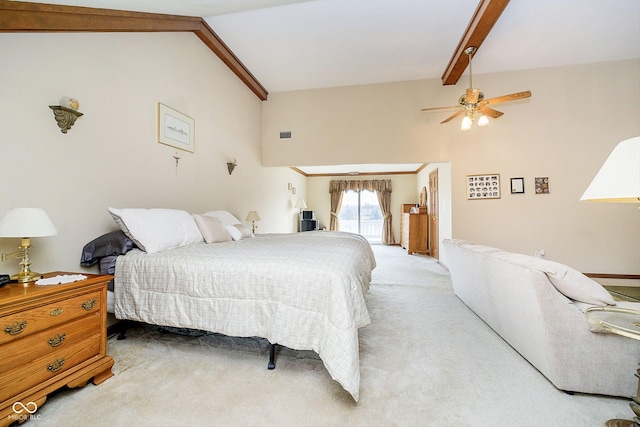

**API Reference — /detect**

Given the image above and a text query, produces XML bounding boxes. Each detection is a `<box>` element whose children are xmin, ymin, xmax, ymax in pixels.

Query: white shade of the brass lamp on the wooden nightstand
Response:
<box><xmin>0</xmin><ymin>208</ymin><xmax>58</xmax><ymax>238</ymax></box>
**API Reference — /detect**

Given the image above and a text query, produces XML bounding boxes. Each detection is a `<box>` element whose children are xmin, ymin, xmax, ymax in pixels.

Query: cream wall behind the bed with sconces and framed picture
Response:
<box><xmin>0</xmin><ymin>33</ymin><xmax>306</xmax><ymax>273</ymax></box>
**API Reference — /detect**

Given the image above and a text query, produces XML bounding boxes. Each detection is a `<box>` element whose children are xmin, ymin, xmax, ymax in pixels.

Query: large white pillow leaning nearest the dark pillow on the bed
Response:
<box><xmin>108</xmin><ymin>207</ymin><xmax>203</xmax><ymax>253</ymax></box>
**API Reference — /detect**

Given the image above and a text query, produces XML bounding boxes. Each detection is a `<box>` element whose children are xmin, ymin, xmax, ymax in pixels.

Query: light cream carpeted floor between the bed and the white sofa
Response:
<box><xmin>32</xmin><ymin>246</ymin><xmax>633</xmax><ymax>427</ymax></box>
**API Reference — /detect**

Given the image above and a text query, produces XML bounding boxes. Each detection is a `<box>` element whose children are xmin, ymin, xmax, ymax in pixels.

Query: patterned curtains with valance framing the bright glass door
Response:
<box><xmin>329</xmin><ymin>179</ymin><xmax>395</xmax><ymax>245</ymax></box>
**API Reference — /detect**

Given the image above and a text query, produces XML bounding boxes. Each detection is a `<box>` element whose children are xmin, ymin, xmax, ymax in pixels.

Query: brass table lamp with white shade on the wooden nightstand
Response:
<box><xmin>0</xmin><ymin>208</ymin><xmax>58</xmax><ymax>283</ymax></box>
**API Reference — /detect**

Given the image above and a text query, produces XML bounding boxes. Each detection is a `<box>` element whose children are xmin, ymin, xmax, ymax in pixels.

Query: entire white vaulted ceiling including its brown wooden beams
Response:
<box><xmin>0</xmin><ymin>0</ymin><xmax>640</xmax><ymax>175</ymax></box>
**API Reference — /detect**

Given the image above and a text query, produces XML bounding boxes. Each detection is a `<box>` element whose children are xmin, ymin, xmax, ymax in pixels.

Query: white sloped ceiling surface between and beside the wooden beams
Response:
<box><xmin>15</xmin><ymin>0</ymin><xmax>640</xmax><ymax>175</ymax></box>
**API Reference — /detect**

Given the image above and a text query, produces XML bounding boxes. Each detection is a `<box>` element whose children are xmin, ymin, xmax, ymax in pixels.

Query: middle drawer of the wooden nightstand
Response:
<box><xmin>0</xmin><ymin>312</ymin><xmax>102</xmax><ymax>374</ymax></box>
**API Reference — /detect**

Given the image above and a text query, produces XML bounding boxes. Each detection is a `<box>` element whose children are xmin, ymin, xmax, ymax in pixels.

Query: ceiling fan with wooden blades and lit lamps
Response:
<box><xmin>420</xmin><ymin>46</ymin><xmax>531</xmax><ymax>130</ymax></box>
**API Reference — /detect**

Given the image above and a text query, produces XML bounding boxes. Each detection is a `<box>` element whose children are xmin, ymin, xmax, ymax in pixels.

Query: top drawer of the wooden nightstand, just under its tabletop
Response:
<box><xmin>0</xmin><ymin>292</ymin><xmax>102</xmax><ymax>344</ymax></box>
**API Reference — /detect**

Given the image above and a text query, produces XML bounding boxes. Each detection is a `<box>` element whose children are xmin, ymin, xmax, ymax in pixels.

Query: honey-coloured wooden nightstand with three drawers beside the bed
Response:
<box><xmin>0</xmin><ymin>271</ymin><xmax>113</xmax><ymax>426</ymax></box>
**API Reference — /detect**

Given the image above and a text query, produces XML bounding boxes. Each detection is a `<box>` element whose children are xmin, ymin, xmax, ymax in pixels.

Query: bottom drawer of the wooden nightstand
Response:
<box><xmin>0</xmin><ymin>335</ymin><xmax>100</xmax><ymax>401</ymax></box>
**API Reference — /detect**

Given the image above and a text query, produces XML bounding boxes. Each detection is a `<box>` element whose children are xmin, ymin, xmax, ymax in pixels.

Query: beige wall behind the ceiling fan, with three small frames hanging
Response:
<box><xmin>263</xmin><ymin>60</ymin><xmax>640</xmax><ymax>274</ymax></box>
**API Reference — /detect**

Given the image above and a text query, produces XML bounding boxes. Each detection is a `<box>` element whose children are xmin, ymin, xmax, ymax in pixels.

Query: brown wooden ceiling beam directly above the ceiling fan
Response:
<box><xmin>442</xmin><ymin>0</ymin><xmax>509</xmax><ymax>86</ymax></box>
